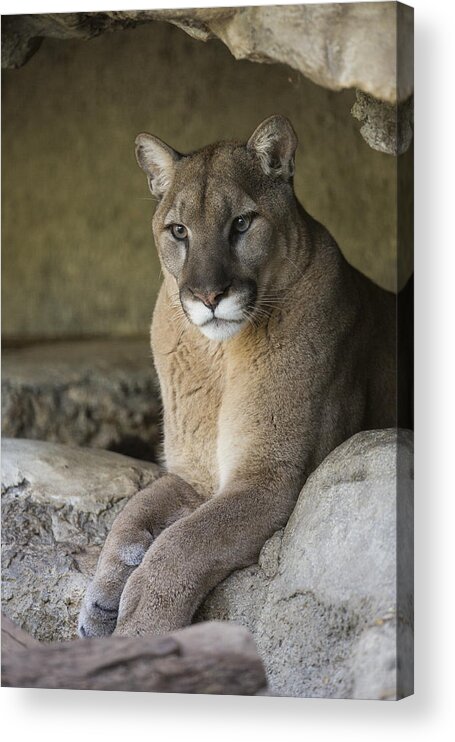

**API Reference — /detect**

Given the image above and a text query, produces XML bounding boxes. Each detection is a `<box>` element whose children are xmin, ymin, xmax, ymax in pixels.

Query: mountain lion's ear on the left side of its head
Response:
<box><xmin>135</xmin><ymin>134</ymin><xmax>182</xmax><ymax>198</ymax></box>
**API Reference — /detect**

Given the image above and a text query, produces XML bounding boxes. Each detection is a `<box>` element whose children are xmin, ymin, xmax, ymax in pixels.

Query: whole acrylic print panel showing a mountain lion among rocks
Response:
<box><xmin>2</xmin><ymin>2</ymin><xmax>413</xmax><ymax>700</ymax></box>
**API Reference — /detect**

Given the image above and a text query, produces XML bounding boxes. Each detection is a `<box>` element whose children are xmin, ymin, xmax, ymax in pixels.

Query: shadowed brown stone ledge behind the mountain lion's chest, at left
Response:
<box><xmin>2</xmin><ymin>339</ymin><xmax>160</xmax><ymax>460</ymax></box>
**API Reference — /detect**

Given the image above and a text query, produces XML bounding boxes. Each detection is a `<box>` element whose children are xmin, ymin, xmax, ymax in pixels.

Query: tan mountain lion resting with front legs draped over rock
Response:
<box><xmin>79</xmin><ymin>116</ymin><xmax>396</xmax><ymax>636</ymax></box>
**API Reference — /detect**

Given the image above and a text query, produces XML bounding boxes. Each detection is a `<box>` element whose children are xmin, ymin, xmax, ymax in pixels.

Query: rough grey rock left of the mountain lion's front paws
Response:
<box><xmin>2</xmin><ymin>439</ymin><xmax>158</xmax><ymax>641</ymax></box>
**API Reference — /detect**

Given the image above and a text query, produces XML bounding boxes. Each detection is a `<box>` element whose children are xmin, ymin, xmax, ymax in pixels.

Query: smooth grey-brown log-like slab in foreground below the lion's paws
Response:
<box><xmin>1</xmin><ymin>614</ymin><xmax>266</xmax><ymax>695</ymax></box>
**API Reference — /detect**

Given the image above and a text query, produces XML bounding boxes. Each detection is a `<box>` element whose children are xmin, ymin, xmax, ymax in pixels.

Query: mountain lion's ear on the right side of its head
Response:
<box><xmin>246</xmin><ymin>115</ymin><xmax>297</xmax><ymax>180</ymax></box>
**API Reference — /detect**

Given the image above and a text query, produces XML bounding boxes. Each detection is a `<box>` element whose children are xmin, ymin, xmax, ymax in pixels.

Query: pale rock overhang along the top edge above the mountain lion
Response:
<box><xmin>2</xmin><ymin>3</ymin><xmax>413</xmax><ymax>103</ymax></box>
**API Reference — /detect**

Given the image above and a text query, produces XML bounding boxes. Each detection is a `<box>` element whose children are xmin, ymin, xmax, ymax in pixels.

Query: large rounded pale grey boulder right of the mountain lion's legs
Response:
<box><xmin>198</xmin><ymin>431</ymin><xmax>413</xmax><ymax>699</ymax></box>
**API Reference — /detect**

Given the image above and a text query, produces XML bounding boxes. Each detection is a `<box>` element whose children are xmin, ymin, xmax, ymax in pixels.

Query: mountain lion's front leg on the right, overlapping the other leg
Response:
<box><xmin>115</xmin><ymin>478</ymin><xmax>299</xmax><ymax>636</ymax></box>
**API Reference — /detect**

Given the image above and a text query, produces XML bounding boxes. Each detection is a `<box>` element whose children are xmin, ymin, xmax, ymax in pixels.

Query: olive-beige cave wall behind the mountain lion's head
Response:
<box><xmin>2</xmin><ymin>23</ymin><xmax>402</xmax><ymax>338</ymax></box>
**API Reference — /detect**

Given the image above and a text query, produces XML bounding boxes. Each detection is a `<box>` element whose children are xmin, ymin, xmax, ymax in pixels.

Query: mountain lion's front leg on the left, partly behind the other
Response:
<box><xmin>78</xmin><ymin>474</ymin><xmax>207</xmax><ymax>637</ymax></box>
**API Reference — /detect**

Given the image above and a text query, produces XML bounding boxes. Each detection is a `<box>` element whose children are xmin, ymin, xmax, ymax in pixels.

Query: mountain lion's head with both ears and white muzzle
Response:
<box><xmin>136</xmin><ymin>116</ymin><xmax>297</xmax><ymax>340</ymax></box>
